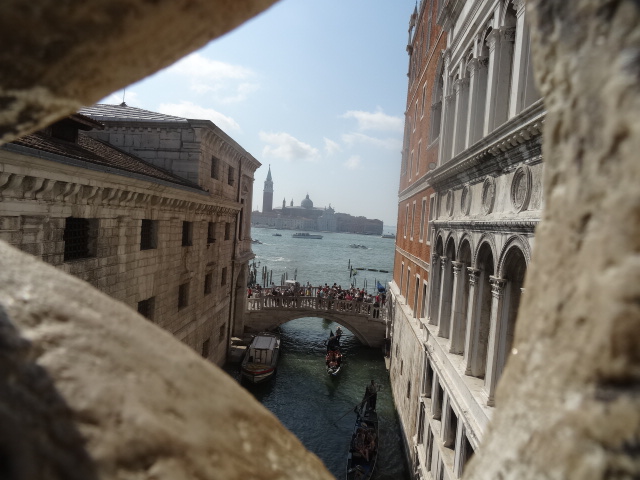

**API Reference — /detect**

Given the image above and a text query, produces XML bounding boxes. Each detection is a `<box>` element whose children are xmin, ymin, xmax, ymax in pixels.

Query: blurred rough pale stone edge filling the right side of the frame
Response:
<box><xmin>464</xmin><ymin>0</ymin><xmax>640</xmax><ymax>480</ymax></box>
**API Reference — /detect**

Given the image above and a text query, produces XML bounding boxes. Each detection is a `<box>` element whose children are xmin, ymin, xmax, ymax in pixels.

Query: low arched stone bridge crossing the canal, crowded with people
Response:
<box><xmin>244</xmin><ymin>295</ymin><xmax>388</xmax><ymax>347</ymax></box>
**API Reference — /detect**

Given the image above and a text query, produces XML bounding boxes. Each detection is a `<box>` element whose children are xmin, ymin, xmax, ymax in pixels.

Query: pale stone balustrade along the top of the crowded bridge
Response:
<box><xmin>247</xmin><ymin>295</ymin><xmax>387</xmax><ymax>321</ymax></box>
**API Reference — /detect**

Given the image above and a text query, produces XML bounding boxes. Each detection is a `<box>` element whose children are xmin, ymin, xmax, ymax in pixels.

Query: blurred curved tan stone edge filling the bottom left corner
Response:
<box><xmin>0</xmin><ymin>242</ymin><xmax>332</xmax><ymax>480</ymax></box>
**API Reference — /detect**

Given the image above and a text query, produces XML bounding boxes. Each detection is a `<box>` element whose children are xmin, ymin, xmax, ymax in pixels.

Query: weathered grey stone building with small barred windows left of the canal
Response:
<box><xmin>0</xmin><ymin>105</ymin><xmax>259</xmax><ymax>364</ymax></box>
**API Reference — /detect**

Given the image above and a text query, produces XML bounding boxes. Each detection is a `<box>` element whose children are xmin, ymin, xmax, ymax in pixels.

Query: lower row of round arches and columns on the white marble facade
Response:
<box><xmin>427</xmin><ymin>231</ymin><xmax>531</xmax><ymax>405</ymax></box>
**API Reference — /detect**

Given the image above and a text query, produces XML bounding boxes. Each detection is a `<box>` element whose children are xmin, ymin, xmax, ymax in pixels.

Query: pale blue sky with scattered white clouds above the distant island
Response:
<box><xmin>101</xmin><ymin>0</ymin><xmax>416</xmax><ymax>231</ymax></box>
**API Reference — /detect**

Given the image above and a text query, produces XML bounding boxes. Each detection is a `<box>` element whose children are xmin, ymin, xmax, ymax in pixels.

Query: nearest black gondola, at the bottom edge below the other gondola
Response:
<box><xmin>345</xmin><ymin>401</ymin><xmax>378</xmax><ymax>480</ymax></box>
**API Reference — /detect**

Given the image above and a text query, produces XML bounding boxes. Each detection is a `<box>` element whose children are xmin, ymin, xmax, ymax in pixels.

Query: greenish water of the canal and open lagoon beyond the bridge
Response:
<box><xmin>225</xmin><ymin>228</ymin><xmax>409</xmax><ymax>480</ymax></box>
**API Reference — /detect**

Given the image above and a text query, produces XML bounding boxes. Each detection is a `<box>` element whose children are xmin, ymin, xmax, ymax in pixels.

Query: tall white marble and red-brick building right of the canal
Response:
<box><xmin>390</xmin><ymin>0</ymin><xmax>545</xmax><ymax>479</ymax></box>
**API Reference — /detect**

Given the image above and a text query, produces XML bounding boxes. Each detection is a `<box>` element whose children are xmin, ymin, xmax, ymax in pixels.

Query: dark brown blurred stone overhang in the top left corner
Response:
<box><xmin>0</xmin><ymin>0</ymin><xmax>275</xmax><ymax>142</ymax></box>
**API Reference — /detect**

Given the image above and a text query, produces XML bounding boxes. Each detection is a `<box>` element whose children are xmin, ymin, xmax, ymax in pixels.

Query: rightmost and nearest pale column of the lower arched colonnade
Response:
<box><xmin>484</xmin><ymin>275</ymin><xmax>507</xmax><ymax>407</ymax></box>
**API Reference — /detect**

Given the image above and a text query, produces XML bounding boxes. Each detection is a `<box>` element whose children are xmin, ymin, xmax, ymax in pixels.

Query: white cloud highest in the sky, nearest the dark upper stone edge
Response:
<box><xmin>167</xmin><ymin>53</ymin><xmax>260</xmax><ymax>103</ymax></box>
